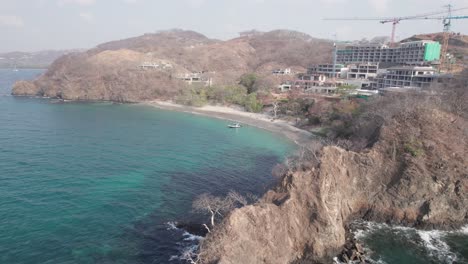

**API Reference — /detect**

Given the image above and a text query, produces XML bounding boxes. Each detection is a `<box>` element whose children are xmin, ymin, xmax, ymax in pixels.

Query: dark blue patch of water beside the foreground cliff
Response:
<box><xmin>124</xmin><ymin>155</ymin><xmax>280</xmax><ymax>263</ymax></box>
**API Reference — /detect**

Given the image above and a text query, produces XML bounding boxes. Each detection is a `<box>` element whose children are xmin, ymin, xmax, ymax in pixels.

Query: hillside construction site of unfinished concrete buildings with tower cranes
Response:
<box><xmin>279</xmin><ymin>5</ymin><xmax>468</xmax><ymax>95</ymax></box>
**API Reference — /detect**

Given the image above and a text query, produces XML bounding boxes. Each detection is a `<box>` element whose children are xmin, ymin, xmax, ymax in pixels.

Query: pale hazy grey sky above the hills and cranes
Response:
<box><xmin>0</xmin><ymin>0</ymin><xmax>468</xmax><ymax>52</ymax></box>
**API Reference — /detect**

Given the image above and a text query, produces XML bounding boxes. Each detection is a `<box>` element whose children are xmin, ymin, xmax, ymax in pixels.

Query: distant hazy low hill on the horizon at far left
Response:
<box><xmin>0</xmin><ymin>50</ymin><xmax>80</xmax><ymax>68</ymax></box>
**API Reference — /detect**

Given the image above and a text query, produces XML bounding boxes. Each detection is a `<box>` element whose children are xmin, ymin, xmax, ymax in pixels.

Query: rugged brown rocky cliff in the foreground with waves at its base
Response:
<box><xmin>200</xmin><ymin>110</ymin><xmax>468</xmax><ymax>263</ymax></box>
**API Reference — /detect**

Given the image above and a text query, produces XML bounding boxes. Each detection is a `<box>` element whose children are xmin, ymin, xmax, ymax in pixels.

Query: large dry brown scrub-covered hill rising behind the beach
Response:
<box><xmin>13</xmin><ymin>30</ymin><xmax>332</xmax><ymax>102</ymax></box>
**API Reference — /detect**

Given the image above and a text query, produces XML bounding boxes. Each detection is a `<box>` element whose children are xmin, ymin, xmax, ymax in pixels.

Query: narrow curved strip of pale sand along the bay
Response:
<box><xmin>142</xmin><ymin>101</ymin><xmax>314</xmax><ymax>146</ymax></box>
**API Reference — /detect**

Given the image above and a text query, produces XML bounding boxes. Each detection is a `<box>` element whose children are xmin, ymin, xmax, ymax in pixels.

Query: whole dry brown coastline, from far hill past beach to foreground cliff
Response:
<box><xmin>8</xmin><ymin>27</ymin><xmax>468</xmax><ymax>264</ymax></box>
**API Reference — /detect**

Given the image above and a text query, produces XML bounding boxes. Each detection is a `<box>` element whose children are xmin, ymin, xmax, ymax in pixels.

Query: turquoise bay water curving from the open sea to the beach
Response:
<box><xmin>0</xmin><ymin>70</ymin><xmax>294</xmax><ymax>263</ymax></box>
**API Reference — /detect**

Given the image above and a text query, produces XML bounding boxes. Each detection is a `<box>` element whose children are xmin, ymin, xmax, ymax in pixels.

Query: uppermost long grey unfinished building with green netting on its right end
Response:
<box><xmin>337</xmin><ymin>40</ymin><xmax>441</xmax><ymax>65</ymax></box>
